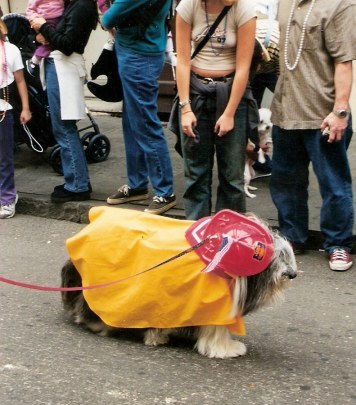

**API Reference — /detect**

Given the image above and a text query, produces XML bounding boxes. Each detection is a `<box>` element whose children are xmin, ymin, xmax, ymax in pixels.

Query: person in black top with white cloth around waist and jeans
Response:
<box><xmin>31</xmin><ymin>0</ymin><xmax>99</xmax><ymax>203</ymax></box>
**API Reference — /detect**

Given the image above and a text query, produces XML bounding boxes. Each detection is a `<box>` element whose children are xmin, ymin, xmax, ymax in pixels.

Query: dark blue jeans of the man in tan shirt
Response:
<box><xmin>270</xmin><ymin>126</ymin><xmax>354</xmax><ymax>252</ymax></box>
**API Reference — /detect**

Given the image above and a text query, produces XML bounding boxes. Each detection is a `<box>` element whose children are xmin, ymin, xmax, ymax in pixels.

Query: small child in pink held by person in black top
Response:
<box><xmin>26</xmin><ymin>0</ymin><xmax>64</xmax><ymax>76</ymax></box>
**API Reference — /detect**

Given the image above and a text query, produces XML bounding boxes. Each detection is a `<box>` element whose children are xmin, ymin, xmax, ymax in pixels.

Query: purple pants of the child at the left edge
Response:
<box><xmin>0</xmin><ymin>110</ymin><xmax>16</xmax><ymax>205</ymax></box>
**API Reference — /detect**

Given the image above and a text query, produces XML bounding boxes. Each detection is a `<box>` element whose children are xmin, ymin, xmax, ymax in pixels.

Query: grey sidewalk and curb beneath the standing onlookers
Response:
<box><xmin>15</xmin><ymin>97</ymin><xmax>356</xmax><ymax>249</ymax></box>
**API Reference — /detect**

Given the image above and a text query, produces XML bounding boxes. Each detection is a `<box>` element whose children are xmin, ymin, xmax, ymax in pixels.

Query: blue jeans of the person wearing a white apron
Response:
<box><xmin>45</xmin><ymin>59</ymin><xmax>89</xmax><ymax>193</ymax></box>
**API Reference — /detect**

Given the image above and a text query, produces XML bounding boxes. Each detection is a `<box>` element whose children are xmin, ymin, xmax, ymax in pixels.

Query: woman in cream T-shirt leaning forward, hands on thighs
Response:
<box><xmin>176</xmin><ymin>0</ymin><xmax>256</xmax><ymax>220</ymax></box>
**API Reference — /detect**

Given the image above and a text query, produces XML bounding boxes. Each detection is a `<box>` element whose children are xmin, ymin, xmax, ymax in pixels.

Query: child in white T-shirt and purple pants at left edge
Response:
<box><xmin>0</xmin><ymin>19</ymin><xmax>31</xmax><ymax>219</ymax></box>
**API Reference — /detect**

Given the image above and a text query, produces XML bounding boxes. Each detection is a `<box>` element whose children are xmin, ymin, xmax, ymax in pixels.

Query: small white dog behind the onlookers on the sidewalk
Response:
<box><xmin>244</xmin><ymin>108</ymin><xmax>273</xmax><ymax>198</ymax></box>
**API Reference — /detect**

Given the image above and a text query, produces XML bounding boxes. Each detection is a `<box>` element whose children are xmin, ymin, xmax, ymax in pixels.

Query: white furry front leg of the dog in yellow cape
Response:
<box><xmin>195</xmin><ymin>326</ymin><xmax>247</xmax><ymax>359</ymax></box>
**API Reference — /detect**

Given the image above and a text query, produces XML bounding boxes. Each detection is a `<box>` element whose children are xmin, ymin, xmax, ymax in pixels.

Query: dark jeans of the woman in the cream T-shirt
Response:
<box><xmin>181</xmin><ymin>97</ymin><xmax>247</xmax><ymax>220</ymax></box>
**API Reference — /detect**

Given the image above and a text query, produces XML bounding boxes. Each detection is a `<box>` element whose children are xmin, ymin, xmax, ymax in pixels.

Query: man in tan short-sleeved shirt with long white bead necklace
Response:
<box><xmin>270</xmin><ymin>0</ymin><xmax>356</xmax><ymax>271</ymax></box>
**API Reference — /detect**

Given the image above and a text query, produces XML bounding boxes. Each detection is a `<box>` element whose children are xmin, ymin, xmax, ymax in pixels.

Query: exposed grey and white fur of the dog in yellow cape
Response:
<box><xmin>62</xmin><ymin>216</ymin><xmax>297</xmax><ymax>358</ymax></box>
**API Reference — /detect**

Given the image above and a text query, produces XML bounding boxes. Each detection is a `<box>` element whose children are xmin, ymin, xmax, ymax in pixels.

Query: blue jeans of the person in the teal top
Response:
<box><xmin>115</xmin><ymin>41</ymin><xmax>173</xmax><ymax>197</ymax></box>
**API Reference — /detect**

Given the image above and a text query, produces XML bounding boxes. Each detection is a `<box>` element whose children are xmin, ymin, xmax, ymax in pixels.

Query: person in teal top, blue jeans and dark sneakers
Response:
<box><xmin>102</xmin><ymin>0</ymin><xmax>176</xmax><ymax>214</ymax></box>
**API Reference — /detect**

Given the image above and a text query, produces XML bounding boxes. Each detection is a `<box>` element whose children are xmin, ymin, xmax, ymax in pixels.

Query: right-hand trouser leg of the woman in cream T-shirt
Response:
<box><xmin>215</xmin><ymin>101</ymin><xmax>247</xmax><ymax>212</ymax></box>
